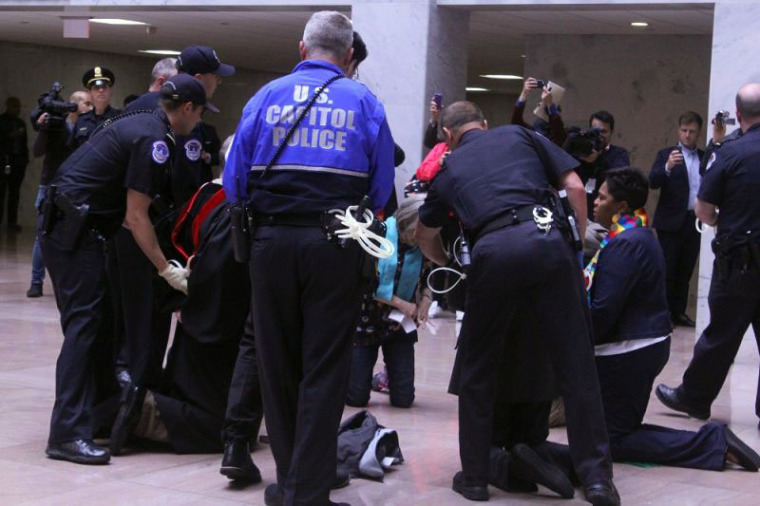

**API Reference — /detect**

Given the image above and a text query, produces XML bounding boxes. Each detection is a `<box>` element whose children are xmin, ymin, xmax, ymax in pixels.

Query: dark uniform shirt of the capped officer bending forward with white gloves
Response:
<box><xmin>52</xmin><ymin>110</ymin><xmax>173</xmax><ymax>225</ymax></box>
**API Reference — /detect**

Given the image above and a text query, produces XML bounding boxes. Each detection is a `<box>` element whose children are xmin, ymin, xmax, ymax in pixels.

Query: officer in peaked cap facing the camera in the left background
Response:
<box><xmin>71</xmin><ymin>67</ymin><xmax>121</xmax><ymax>149</ymax></box>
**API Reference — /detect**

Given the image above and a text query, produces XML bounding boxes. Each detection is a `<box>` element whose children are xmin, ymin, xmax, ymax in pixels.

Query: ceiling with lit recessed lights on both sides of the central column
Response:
<box><xmin>0</xmin><ymin>4</ymin><xmax>713</xmax><ymax>92</ymax></box>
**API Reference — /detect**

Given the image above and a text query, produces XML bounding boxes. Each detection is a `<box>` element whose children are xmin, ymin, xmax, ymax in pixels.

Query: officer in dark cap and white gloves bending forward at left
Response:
<box><xmin>39</xmin><ymin>76</ymin><xmax>213</xmax><ymax>464</ymax></box>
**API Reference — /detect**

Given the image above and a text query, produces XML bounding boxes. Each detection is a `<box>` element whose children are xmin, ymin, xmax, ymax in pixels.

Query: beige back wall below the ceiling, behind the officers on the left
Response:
<box><xmin>0</xmin><ymin>42</ymin><xmax>282</xmax><ymax>226</ymax></box>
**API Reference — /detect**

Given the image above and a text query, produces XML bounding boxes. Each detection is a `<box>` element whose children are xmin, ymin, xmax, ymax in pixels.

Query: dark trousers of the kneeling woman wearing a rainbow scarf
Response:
<box><xmin>596</xmin><ymin>338</ymin><xmax>726</xmax><ymax>471</ymax></box>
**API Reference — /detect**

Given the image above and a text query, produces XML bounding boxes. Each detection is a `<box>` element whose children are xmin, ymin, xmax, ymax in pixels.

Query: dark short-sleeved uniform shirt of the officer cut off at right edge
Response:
<box><xmin>697</xmin><ymin>123</ymin><xmax>760</xmax><ymax>239</ymax></box>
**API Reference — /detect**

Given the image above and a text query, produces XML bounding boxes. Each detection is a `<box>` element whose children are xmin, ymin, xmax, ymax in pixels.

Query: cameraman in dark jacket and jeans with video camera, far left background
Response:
<box><xmin>26</xmin><ymin>91</ymin><xmax>92</xmax><ymax>297</ymax></box>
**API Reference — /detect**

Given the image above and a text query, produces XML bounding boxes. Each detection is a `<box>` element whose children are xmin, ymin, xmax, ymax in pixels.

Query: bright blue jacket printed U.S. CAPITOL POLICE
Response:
<box><xmin>223</xmin><ymin>60</ymin><xmax>394</xmax><ymax>214</ymax></box>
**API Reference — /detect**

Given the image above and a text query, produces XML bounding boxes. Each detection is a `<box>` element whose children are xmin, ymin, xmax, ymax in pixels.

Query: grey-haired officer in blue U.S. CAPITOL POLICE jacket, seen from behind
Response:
<box><xmin>224</xmin><ymin>11</ymin><xmax>394</xmax><ymax>506</ymax></box>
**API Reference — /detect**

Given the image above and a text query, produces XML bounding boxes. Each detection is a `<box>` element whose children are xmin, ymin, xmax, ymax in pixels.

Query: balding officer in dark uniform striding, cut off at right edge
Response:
<box><xmin>656</xmin><ymin>83</ymin><xmax>760</xmax><ymax>420</ymax></box>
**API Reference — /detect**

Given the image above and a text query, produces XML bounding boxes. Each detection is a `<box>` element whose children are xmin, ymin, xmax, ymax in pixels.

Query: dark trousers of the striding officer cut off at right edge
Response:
<box><xmin>682</xmin><ymin>261</ymin><xmax>760</xmax><ymax>417</ymax></box>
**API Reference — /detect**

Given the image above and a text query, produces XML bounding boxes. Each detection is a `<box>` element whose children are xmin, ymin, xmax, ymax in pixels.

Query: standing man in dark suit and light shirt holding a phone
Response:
<box><xmin>649</xmin><ymin>111</ymin><xmax>704</xmax><ymax>327</ymax></box>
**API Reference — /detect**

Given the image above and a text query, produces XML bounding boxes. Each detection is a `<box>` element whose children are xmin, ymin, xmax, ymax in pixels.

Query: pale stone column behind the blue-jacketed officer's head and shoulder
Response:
<box><xmin>351</xmin><ymin>0</ymin><xmax>469</xmax><ymax>200</ymax></box>
